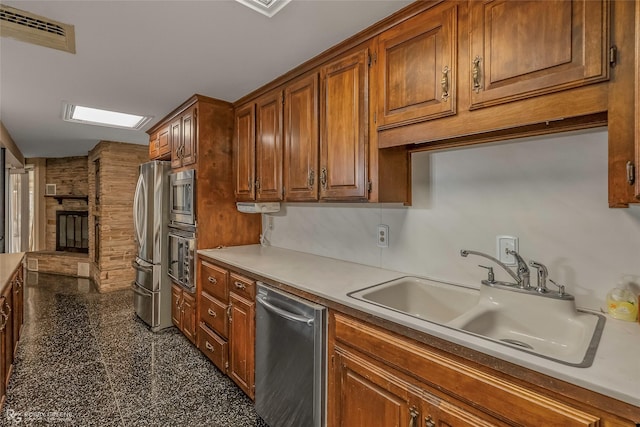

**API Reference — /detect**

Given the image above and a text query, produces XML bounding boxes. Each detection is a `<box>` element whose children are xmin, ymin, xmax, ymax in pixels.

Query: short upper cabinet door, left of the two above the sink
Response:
<box><xmin>375</xmin><ymin>3</ymin><xmax>457</xmax><ymax>129</ymax></box>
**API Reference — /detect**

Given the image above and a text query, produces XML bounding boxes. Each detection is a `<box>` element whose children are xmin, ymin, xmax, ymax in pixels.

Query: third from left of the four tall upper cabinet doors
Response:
<box><xmin>284</xmin><ymin>74</ymin><xmax>319</xmax><ymax>201</ymax></box>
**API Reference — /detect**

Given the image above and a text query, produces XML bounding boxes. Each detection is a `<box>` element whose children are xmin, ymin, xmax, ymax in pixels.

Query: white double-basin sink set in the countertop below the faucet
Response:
<box><xmin>349</xmin><ymin>277</ymin><xmax>605</xmax><ymax>367</ymax></box>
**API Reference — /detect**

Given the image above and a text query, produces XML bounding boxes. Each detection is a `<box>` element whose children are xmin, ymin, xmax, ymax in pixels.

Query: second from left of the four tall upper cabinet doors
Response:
<box><xmin>255</xmin><ymin>91</ymin><xmax>282</xmax><ymax>201</ymax></box>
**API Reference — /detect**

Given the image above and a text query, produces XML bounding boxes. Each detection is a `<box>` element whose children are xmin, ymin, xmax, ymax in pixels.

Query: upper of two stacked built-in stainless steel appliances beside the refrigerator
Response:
<box><xmin>169</xmin><ymin>169</ymin><xmax>196</xmax><ymax>226</ymax></box>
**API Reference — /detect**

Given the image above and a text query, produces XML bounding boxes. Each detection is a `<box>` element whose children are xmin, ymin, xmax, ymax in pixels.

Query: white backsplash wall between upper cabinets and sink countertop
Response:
<box><xmin>268</xmin><ymin>128</ymin><xmax>640</xmax><ymax>309</ymax></box>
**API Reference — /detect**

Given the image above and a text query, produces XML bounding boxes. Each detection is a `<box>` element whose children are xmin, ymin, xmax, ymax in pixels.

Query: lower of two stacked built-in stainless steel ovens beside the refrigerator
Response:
<box><xmin>167</xmin><ymin>228</ymin><xmax>196</xmax><ymax>292</ymax></box>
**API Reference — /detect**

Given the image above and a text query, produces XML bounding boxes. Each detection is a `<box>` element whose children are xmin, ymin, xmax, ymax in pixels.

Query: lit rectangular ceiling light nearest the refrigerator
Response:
<box><xmin>62</xmin><ymin>102</ymin><xmax>152</xmax><ymax>130</ymax></box>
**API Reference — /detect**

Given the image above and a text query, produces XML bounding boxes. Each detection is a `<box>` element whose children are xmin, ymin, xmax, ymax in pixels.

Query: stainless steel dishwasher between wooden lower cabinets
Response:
<box><xmin>255</xmin><ymin>282</ymin><xmax>327</xmax><ymax>427</ymax></box>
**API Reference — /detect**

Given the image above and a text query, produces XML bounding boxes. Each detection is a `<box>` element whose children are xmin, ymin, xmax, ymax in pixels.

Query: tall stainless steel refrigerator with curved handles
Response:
<box><xmin>131</xmin><ymin>160</ymin><xmax>172</xmax><ymax>332</ymax></box>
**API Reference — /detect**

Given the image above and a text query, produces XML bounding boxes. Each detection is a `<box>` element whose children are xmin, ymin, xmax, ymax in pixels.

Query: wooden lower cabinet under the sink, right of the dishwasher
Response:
<box><xmin>328</xmin><ymin>312</ymin><xmax>634</xmax><ymax>427</ymax></box>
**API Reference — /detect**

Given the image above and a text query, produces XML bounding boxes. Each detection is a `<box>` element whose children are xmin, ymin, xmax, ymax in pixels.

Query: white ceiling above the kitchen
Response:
<box><xmin>0</xmin><ymin>0</ymin><xmax>411</xmax><ymax>157</ymax></box>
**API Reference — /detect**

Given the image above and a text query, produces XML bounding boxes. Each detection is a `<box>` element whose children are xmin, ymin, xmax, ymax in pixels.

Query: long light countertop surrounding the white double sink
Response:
<box><xmin>198</xmin><ymin>245</ymin><xmax>640</xmax><ymax>406</ymax></box>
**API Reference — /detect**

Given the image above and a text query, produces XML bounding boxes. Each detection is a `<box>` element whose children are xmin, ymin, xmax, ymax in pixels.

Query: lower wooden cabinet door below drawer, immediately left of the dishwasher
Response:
<box><xmin>228</xmin><ymin>292</ymin><xmax>255</xmax><ymax>399</ymax></box>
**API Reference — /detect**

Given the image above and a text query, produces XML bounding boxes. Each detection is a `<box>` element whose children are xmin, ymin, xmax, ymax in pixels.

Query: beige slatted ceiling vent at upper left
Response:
<box><xmin>0</xmin><ymin>4</ymin><xmax>76</xmax><ymax>53</ymax></box>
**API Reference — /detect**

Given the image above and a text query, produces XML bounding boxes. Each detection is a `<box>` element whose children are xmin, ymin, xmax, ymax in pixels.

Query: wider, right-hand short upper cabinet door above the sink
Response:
<box><xmin>469</xmin><ymin>0</ymin><xmax>609</xmax><ymax>109</ymax></box>
